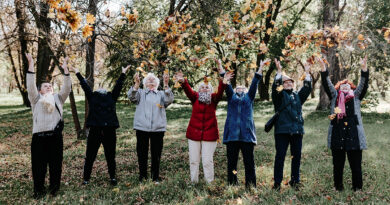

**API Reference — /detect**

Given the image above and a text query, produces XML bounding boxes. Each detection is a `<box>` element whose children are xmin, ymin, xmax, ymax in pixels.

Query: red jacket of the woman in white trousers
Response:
<box><xmin>181</xmin><ymin>79</ymin><xmax>226</xmax><ymax>141</ymax></box>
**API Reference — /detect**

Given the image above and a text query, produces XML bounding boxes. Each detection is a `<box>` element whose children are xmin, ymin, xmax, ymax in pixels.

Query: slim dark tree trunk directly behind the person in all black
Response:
<box><xmin>83</xmin><ymin>0</ymin><xmax>98</xmax><ymax>136</ymax></box>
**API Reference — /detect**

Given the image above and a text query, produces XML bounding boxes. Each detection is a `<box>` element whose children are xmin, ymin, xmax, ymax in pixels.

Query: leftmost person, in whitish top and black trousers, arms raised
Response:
<box><xmin>26</xmin><ymin>54</ymin><xmax>72</xmax><ymax>198</ymax></box>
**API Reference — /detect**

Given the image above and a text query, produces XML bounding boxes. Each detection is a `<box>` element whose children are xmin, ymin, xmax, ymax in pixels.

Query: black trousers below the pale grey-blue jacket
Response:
<box><xmin>136</xmin><ymin>130</ymin><xmax>164</xmax><ymax>181</ymax></box>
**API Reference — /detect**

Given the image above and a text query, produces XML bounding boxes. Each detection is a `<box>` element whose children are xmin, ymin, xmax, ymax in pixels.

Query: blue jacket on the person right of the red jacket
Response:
<box><xmin>223</xmin><ymin>73</ymin><xmax>262</xmax><ymax>144</ymax></box>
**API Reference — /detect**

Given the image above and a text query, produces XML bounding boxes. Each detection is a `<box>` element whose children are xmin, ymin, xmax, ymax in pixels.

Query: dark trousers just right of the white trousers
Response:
<box><xmin>226</xmin><ymin>141</ymin><xmax>256</xmax><ymax>187</ymax></box>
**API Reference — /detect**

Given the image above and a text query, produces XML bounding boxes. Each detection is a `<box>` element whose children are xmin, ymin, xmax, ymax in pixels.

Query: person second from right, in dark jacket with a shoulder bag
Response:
<box><xmin>272</xmin><ymin>59</ymin><xmax>312</xmax><ymax>190</ymax></box>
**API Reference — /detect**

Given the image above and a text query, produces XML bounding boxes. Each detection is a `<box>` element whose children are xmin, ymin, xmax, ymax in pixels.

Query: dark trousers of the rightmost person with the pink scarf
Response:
<box><xmin>332</xmin><ymin>149</ymin><xmax>363</xmax><ymax>191</ymax></box>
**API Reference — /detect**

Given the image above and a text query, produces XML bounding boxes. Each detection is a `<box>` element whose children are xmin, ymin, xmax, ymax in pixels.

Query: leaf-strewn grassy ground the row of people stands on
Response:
<box><xmin>0</xmin><ymin>93</ymin><xmax>390</xmax><ymax>204</ymax></box>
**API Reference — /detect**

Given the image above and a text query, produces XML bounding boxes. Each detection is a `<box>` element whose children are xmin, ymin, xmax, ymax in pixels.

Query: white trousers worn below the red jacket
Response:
<box><xmin>188</xmin><ymin>139</ymin><xmax>217</xmax><ymax>183</ymax></box>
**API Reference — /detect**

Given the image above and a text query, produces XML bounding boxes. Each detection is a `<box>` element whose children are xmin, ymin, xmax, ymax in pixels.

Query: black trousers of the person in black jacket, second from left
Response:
<box><xmin>84</xmin><ymin>127</ymin><xmax>116</xmax><ymax>181</ymax></box>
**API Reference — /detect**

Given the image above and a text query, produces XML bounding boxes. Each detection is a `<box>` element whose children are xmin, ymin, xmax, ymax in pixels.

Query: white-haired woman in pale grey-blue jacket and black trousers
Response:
<box><xmin>127</xmin><ymin>73</ymin><xmax>173</xmax><ymax>182</ymax></box>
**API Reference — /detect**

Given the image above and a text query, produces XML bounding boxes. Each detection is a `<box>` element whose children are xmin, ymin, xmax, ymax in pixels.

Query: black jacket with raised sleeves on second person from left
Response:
<box><xmin>76</xmin><ymin>73</ymin><xmax>125</xmax><ymax>128</ymax></box>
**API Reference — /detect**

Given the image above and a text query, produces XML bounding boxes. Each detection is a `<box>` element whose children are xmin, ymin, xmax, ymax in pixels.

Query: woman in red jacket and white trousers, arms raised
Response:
<box><xmin>175</xmin><ymin>69</ymin><xmax>232</xmax><ymax>183</ymax></box>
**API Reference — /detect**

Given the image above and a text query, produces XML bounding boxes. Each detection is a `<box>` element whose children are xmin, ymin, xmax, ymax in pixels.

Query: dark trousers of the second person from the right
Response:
<box><xmin>274</xmin><ymin>134</ymin><xmax>303</xmax><ymax>185</ymax></box>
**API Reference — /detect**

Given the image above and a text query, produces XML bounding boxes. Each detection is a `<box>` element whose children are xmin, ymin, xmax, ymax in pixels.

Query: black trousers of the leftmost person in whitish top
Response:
<box><xmin>31</xmin><ymin>132</ymin><xmax>63</xmax><ymax>195</ymax></box>
